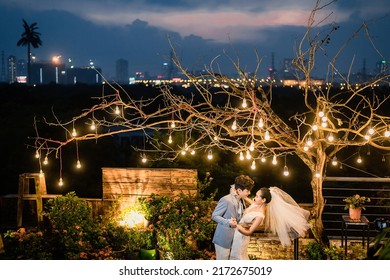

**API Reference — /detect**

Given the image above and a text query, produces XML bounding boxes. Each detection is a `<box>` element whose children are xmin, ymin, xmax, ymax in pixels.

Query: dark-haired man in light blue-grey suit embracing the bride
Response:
<box><xmin>211</xmin><ymin>175</ymin><xmax>254</xmax><ymax>260</ymax></box>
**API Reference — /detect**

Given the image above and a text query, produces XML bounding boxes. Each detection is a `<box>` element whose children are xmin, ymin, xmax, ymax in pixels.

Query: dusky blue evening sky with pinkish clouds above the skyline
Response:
<box><xmin>0</xmin><ymin>0</ymin><xmax>390</xmax><ymax>78</ymax></box>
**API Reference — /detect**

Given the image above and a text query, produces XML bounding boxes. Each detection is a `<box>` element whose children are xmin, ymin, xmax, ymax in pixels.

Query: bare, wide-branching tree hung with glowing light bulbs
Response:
<box><xmin>35</xmin><ymin>0</ymin><xmax>390</xmax><ymax>243</ymax></box>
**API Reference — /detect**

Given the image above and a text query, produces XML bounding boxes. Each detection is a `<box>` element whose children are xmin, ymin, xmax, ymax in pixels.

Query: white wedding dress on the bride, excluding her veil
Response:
<box><xmin>230</xmin><ymin>211</ymin><xmax>264</xmax><ymax>260</ymax></box>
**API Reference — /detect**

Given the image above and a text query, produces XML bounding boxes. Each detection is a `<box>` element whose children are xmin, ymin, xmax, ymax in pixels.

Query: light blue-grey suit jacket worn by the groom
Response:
<box><xmin>211</xmin><ymin>194</ymin><xmax>244</xmax><ymax>249</ymax></box>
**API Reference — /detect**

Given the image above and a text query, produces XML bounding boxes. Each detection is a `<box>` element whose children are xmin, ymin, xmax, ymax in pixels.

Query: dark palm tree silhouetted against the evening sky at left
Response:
<box><xmin>17</xmin><ymin>19</ymin><xmax>42</xmax><ymax>84</ymax></box>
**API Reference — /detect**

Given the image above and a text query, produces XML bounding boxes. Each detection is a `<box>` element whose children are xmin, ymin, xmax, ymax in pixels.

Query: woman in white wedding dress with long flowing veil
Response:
<box><xmin>230</xmin><ymin>187</ymin><xmax>310</xmax><ymax>260</ymax></box>
